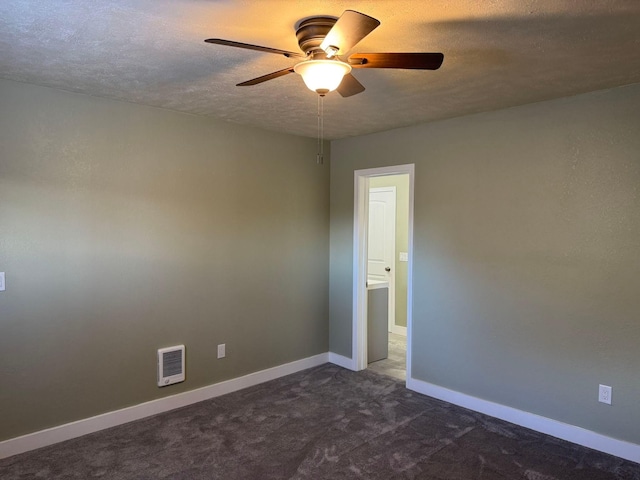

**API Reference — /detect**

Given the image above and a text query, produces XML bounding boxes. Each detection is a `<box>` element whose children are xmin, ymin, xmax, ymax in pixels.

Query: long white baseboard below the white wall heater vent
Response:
<box><xmin>0</xmin><ymin>353</ymin><xmax>329</xmax><ymax>458</ymax></box>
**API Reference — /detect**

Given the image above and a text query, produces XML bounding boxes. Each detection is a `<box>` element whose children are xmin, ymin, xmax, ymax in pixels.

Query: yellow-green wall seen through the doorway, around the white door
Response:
<box><xmin>369</xmin><ymin>175</ymin><xmax>409</xmax><ymax>327</ymax></box>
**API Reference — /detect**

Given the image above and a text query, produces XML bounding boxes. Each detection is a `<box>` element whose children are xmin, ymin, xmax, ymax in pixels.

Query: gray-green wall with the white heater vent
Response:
<box><xmin>0</xmin><ymin>81</ymin><xmax>329</xmax><ymax>440</ymax></box>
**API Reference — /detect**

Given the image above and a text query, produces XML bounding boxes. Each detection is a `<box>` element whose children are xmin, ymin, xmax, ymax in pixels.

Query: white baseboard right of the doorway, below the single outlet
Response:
<box><xmin>407</xmin><ymin>378</ymin><xmax>640</xmax><ymax>463</ymax></box>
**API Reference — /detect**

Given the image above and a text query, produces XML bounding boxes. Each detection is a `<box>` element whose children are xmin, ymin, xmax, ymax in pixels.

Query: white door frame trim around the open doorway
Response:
<box><xmin>351</xmin><ymin>164</ymin><xmax>415</xmax><ymax>380</ymax></box>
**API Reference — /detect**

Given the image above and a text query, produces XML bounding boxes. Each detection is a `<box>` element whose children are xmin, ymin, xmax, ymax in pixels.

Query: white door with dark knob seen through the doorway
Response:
<box><xmin>367</xmin><ymin>187</ymin><xmax>396</xmax><ymax>331</ymax></box>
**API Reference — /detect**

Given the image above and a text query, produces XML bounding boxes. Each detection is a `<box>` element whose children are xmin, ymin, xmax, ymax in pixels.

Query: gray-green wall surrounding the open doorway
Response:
<box><xmin>330</xmin><ymin>85</ymin><xmax>640</xmax><ymax>444</ymax></box>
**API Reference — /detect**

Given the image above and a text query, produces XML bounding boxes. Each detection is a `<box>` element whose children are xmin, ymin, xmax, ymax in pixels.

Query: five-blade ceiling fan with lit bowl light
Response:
<box><xmin>205</xmin><ymin>10</ymin><xmax>444</xmax><ymax>97</ymax></box>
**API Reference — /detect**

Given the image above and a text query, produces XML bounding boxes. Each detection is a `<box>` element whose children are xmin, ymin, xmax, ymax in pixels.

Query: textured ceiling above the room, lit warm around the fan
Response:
<box><xmin>0</xmin><ymin>0</ymin><xmax>640</xmax><ymax>139</ymax></box>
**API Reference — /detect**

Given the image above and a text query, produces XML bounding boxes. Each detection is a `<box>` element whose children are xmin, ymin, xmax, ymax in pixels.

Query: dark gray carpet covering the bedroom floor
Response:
<box><xmin>0</xmin><ymin>364</ymin><xmax>640</xmax><ymax>480</ymax></box>
